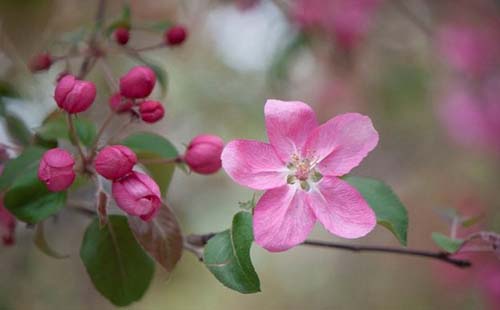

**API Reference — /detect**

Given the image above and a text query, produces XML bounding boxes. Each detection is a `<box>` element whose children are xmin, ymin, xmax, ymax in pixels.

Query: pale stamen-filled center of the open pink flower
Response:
<box><xmin>287</xmin><ymin>154</ymin><xmax>323</xmax><ymax>191</ymax></box>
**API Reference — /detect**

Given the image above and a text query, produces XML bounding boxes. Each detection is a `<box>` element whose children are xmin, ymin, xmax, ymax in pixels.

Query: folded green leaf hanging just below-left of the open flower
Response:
<box><xmin>203</xmin><ymin>211</ymin><xmax>260</xmax><ymax>294</ymax></box>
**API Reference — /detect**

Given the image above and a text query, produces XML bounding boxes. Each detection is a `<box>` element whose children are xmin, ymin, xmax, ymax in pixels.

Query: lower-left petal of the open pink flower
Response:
<box><xmin>253</xmin><ymin>185</ymin><xmax>316</xmax><ymax>252</ymax></box>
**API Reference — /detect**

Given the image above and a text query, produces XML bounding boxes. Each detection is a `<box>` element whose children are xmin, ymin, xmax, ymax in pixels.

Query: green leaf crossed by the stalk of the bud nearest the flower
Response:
<box><xmin>122</xmin><ymin>133</ymin><xmax>179</xmax><ymax>196</ymax></box>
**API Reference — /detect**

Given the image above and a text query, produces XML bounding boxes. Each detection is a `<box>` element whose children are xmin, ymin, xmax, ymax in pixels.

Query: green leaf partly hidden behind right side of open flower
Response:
<box><xmin>344</xmin><ymin>176</ymin><xmax>408</xmax><ymax>246</ymax></box>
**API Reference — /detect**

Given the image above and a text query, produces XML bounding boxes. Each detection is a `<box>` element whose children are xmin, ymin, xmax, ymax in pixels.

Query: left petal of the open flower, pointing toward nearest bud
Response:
<box><xmin>221</xmin><ymin>140</ymin><xmax>287</xmax><ymax>190</ymax></box>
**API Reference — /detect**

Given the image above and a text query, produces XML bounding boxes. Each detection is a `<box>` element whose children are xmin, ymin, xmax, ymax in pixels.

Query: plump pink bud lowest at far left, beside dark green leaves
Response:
<box><xmin>38</xmin><ymin>148</ymin><xmax>76</xmax><ymax>192</ymax></box>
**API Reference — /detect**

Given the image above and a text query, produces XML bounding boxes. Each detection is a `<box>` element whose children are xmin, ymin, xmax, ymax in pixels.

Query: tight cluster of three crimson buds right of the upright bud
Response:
<box><xmin>109</xmin><ymin>66</ymin><xmax>165</xmax><ymax>123</ymax></box>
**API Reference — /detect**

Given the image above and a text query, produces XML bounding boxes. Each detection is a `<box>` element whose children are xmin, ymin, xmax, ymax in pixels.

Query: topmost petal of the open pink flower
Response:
<box><xmin>264</xmin><ymin>99</ymin><xmax>318</xmax><ymax>162</ymax></box>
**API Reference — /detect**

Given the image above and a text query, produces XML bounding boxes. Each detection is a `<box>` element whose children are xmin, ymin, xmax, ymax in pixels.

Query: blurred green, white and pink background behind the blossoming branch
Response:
<box><xmin>0</xmin><ymin>0</ymin><xmax>500</xmax><ymax>309</ymax></box>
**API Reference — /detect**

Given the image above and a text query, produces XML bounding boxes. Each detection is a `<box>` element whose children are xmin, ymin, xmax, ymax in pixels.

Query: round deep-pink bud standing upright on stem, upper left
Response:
<box><xmin>54</xmin><ymin>74</ymin><xmax>96</xmax><ymax>114</ymax></box>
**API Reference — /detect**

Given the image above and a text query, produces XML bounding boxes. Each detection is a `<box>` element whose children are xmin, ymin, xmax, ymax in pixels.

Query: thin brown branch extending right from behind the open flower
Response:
<box><xmin>186</xmin><ymin>233</ymin><xmax>471</xmax><ymax>268</ymax></box>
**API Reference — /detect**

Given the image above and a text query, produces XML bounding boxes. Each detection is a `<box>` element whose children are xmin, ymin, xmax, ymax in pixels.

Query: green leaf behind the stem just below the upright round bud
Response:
<box><xmin>37</xmin><ymin>115</ymin><xmax>97</xmax><ymax>146</ymax></box>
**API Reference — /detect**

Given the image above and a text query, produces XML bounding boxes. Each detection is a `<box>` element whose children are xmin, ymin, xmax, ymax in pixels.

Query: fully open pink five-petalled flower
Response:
<box><xmin>222</xmin><ymin>100</ymin><xmax>378</xmax><ymax>252</ymax></box>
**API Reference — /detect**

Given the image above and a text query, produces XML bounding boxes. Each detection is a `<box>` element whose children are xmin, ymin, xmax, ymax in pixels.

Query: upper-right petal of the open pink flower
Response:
<box><xmin>303</xmin><ymin>113</ymin><xmax>378</xmax><ymax>176</ymax></box>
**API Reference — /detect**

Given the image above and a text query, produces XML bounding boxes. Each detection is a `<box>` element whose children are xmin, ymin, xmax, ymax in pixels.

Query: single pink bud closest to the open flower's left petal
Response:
<box><xmin>184</xmin><ymin>135</ymin><xmax>224</xmax><ymax>174</ymax></box>
